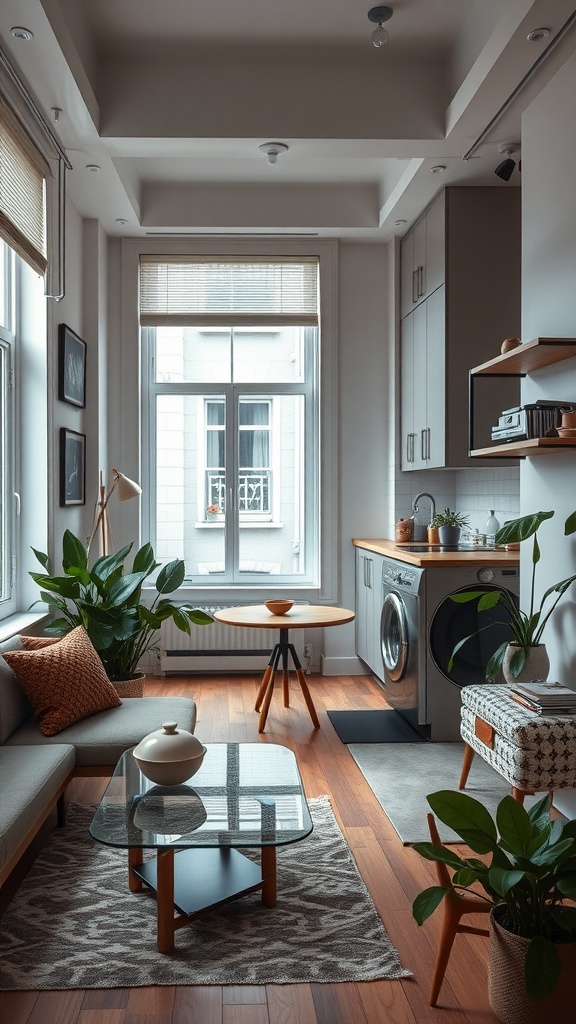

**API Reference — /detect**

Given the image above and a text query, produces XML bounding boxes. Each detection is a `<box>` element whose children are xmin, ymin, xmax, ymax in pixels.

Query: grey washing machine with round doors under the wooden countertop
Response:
<box><xmin>380</xmin><ymin>558</ymin><xmax>520</xmax><ymax>741</ymax></box>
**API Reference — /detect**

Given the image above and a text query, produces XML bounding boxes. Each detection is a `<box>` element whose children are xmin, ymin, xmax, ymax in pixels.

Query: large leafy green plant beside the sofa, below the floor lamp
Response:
<box><xmin>30</xmin><ymin>529</ymin><xmax>213</xmax><ymax>679</ymax></box>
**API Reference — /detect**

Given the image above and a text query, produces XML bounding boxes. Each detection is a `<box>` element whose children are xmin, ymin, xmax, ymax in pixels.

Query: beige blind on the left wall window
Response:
<box><xmin>0</xmin><ymin>97</ymin><xmax>49</xmax><ymax>274</ymax></box>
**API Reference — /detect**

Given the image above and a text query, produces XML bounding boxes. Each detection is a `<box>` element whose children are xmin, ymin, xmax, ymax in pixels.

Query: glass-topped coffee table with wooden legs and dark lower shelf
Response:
<box><xmin>90</xmin><ymin>743</ymin><xmax>313</xmax><ymax>953</ymax></box>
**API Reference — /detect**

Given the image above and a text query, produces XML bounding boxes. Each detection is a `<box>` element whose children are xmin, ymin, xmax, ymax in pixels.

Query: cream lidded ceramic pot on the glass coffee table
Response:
<box><xmin>132</xmin><ymin>722</ymin><xmax>206</xmax><ymax>785</ymax></box>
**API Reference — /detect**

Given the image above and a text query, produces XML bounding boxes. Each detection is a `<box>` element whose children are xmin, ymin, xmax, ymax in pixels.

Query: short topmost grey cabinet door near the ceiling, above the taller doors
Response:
<box><xmin>401</xmin><ymin>193</ymin><xmax>445</xmax><ymax>316</ymax></box>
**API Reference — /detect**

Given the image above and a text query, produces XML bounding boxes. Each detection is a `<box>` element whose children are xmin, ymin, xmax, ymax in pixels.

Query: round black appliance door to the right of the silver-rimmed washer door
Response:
<box><xmin>428</xmin><ymin>584</ymin><xmax>518</xmax><ymax>686</ymax></box>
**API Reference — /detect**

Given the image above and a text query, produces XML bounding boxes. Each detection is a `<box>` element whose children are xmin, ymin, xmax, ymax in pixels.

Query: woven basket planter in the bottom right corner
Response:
<box><xmin>488</xmin><ymin>911</ymin><xmax>576</xmax><ymax>1024</ymax></box>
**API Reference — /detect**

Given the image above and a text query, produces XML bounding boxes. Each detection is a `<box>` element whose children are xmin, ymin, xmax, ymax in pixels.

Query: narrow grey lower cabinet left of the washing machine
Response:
<box><xmin>356</xmin><ymin>548</ymin><xmax>384</xmax><ymax>679</ymax></box>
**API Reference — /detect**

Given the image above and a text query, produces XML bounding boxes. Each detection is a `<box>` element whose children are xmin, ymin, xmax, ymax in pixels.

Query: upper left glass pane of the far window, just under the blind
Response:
<box><xmin>155</xmin><ymin>327</ymin><xmax>232</xmax><ymax>384</ymax></box>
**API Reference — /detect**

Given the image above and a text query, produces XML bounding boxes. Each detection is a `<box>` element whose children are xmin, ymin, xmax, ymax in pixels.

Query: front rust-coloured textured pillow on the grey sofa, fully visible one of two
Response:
<box><xmin>4</xmin><ymin>626</ymin><xmax>122</xmax><ymax>736</ymax></box>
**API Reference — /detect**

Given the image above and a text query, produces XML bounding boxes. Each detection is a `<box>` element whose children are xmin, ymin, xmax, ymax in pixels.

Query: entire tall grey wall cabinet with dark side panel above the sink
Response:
<box><xmin>401</xmin><ymin>186</ymin><xmax>521</xmax><ymax>470</ymax></box>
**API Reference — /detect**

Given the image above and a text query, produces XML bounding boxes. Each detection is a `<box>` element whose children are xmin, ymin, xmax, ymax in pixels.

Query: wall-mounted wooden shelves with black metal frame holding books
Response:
<box><xmin>468</xmin><ymin>338</ymin><xmax>576</xmax><ymax>459</ymax></box>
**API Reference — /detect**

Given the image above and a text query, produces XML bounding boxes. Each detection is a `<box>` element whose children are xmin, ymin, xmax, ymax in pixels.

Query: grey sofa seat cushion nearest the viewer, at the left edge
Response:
<box><xmin>0</xmin><ymin>743</ymin><xmax>76</xmax><ymax>871</ymax></box>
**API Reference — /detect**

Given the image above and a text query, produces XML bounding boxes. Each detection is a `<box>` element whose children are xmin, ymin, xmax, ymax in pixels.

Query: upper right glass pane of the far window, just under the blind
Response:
<box><xmin>234</xmin><ymin>327</ymin><xmax>311</xmax><ymax>384</ymax></box>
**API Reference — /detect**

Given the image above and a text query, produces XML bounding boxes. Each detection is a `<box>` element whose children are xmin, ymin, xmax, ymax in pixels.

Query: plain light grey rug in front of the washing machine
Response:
<box><xmin>348</xmin><ymin>742</ymin><xmax>532</xmax><ymax>846</ymax></box>
